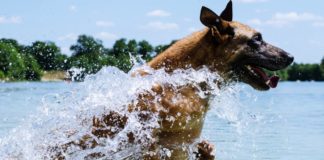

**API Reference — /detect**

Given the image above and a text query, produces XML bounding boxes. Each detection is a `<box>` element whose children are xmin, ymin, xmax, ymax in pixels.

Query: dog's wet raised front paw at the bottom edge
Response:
<box><xmin>195</xmin><ymin>141</ymin><xmax>215</xmax><ymax>160</ymax></box>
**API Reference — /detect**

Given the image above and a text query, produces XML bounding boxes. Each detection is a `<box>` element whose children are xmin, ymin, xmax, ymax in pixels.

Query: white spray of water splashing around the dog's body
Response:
<box><xmin>0</xmin><ymin>63</ymin><xmax>253</xmax><ymax>159</ymax></box>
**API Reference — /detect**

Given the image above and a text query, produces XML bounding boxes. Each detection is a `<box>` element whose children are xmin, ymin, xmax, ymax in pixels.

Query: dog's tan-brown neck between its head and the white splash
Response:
<box><xmin>148</xmin><ymin>28</ymin><xmax>225</xmax><ymax>72</ymax></box>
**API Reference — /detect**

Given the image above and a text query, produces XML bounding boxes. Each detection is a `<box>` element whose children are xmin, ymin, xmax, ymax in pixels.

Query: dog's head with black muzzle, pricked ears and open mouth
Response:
<box><xmin>200</xmin><ymin>1</ymin><xmax>294</xmax><ymax>90</ymax></box>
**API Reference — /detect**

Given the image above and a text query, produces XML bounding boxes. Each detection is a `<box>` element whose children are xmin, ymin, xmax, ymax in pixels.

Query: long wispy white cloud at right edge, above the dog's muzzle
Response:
<box><xmin>248</xmin><ymin>12</ymin><xmax>324</xmax><ymax>27</ymax></box>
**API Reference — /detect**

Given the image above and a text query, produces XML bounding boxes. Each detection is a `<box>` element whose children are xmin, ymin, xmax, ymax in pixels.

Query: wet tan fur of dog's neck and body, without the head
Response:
<box><xmin>54</xmin><ymin>24</ymin><xmax>251</xmax><ymax>160</ymax></box>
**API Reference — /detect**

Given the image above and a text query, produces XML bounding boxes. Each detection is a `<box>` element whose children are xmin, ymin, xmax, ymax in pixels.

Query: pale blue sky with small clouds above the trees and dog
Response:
<box><xmin>0</xmin><ymin>0</ymin><xmax>324</xmax><ymax>63</ymax></box>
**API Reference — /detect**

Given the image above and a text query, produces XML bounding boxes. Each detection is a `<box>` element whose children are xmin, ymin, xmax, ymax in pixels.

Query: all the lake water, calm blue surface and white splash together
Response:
<box><xmin>0</xmin><ymin>68</ymin><xmax>324</xmax><ymax>160</ymax></box>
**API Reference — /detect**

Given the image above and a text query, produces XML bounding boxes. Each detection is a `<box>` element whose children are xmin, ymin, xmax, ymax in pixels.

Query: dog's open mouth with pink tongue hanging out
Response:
<box><xmin>245</xmin><ymin>65</ymin><xmax>280</xmax><ymax>88</ymax></box>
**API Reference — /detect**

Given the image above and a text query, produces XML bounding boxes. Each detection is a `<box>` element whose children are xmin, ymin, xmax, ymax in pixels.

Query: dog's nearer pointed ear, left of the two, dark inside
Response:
<box><xmin>200</xmin><ymin>6</ymin><xmax>222</xmax><ymax>28</ymax></box>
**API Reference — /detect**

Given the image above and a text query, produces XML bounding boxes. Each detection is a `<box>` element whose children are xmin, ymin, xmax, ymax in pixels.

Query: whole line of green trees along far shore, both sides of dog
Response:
<box><xmin>0</xmin><ymin>35</ymin><xmax>324</xmax><ymax>81</ymax></box>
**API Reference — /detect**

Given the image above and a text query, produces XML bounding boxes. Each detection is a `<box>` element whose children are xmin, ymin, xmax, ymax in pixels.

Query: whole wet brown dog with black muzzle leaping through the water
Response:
<box><xmin>53</xmin><ymin>1</ymin><xmax>293</xmax><ymax>160</ymax></box>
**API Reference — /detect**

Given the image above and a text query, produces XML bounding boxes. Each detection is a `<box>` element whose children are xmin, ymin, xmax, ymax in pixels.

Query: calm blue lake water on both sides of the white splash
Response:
<box><xmin>0</xmin><ymin>82</ymin><xmax>324</xmax><ymax>160</ymax></box>
